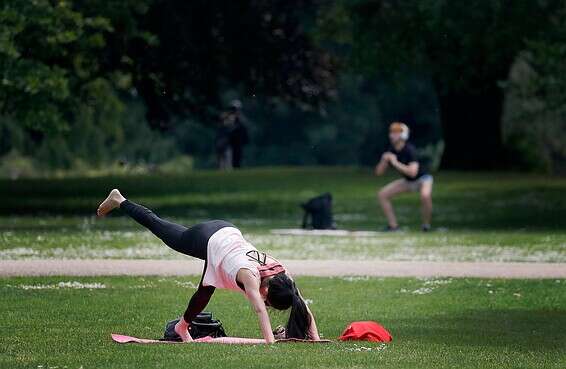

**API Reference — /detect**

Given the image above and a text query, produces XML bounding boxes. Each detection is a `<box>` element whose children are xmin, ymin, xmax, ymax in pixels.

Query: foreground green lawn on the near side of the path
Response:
<box><xmin>0</xmin><ymin>277</ymin><xmax>566</xmax><ymax>369</ymax></box>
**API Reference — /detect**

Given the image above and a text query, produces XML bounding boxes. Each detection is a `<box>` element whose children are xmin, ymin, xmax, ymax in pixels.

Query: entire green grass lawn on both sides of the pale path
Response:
<box><xmin>0</xmin><ymin>168</ymin><xmax>566</xmax><ymax>369</ymax></box>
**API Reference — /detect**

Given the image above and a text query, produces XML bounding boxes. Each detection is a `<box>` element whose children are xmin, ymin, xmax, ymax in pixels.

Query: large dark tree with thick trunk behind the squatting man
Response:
<box><xmin>320</xmin><ymin>0</ymin><xmax>563</xmax><ymax>168</ymax></box>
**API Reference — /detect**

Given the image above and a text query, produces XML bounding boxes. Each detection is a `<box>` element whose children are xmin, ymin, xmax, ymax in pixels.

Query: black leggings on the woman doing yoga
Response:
<box><xmin>120</xmin><ymin>200</ymin><xmax>234</xmax><ymax>324</ymax></box>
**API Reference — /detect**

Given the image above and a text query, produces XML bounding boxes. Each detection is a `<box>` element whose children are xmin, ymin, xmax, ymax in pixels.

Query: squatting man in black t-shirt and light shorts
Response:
<box><xmin>375</xmin><ymin>122</ymin><xmax>433</xmax><ymax>232</ymax></box>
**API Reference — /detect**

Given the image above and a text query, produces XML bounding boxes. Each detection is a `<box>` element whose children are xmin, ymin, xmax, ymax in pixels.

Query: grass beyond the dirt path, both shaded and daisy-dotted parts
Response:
<box><xmin>0</xmin><ymin>168</ymin><xmax>566</xmax><ymax>262</ymax></box>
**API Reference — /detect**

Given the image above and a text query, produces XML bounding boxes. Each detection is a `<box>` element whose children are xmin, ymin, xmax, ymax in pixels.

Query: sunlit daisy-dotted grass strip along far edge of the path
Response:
<box><xmin>0</xmin><ymin>227</ymin><xmax>566</xmax><ymax>263</ymax></box>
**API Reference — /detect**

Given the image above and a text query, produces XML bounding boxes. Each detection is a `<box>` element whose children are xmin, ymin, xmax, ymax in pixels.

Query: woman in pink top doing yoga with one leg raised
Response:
<box><xmin>97</xmin><ymin>189</ymin><xmax>320</xmax><ymax>343</ymax></box>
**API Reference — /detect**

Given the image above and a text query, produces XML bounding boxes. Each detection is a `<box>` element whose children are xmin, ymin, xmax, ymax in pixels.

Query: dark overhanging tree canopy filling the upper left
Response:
<box><xmin>0</xmin><ymin>0</ymin><xmax>334</xmax><ymax>131</ymax></box>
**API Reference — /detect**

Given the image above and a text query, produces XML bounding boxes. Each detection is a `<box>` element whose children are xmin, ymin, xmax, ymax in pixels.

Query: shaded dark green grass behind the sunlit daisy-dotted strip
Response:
<box><xmin>4</xmin><ymin>167</ymin><xmax>566</xmax><ymax>230</ymax></box>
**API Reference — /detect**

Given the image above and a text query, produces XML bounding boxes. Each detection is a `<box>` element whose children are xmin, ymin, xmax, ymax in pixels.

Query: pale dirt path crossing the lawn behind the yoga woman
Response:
<box><xmin>0</xmin><ymin>259</ymin><xmax>566</xmax><ymax>279</ymax></box>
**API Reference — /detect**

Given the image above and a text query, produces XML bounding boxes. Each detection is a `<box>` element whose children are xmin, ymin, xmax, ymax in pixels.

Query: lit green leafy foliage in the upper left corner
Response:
<box><xmin>0</xmin><ymin>0</ymin><xmax>112</xmax><ymax>131</ymax></box>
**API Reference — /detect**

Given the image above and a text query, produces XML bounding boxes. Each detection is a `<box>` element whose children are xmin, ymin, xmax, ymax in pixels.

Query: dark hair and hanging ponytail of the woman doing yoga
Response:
<box><xmin>267</xmin><ymin>273</ymin><xmax>310</xmax><ymax>339</ymax></box>
